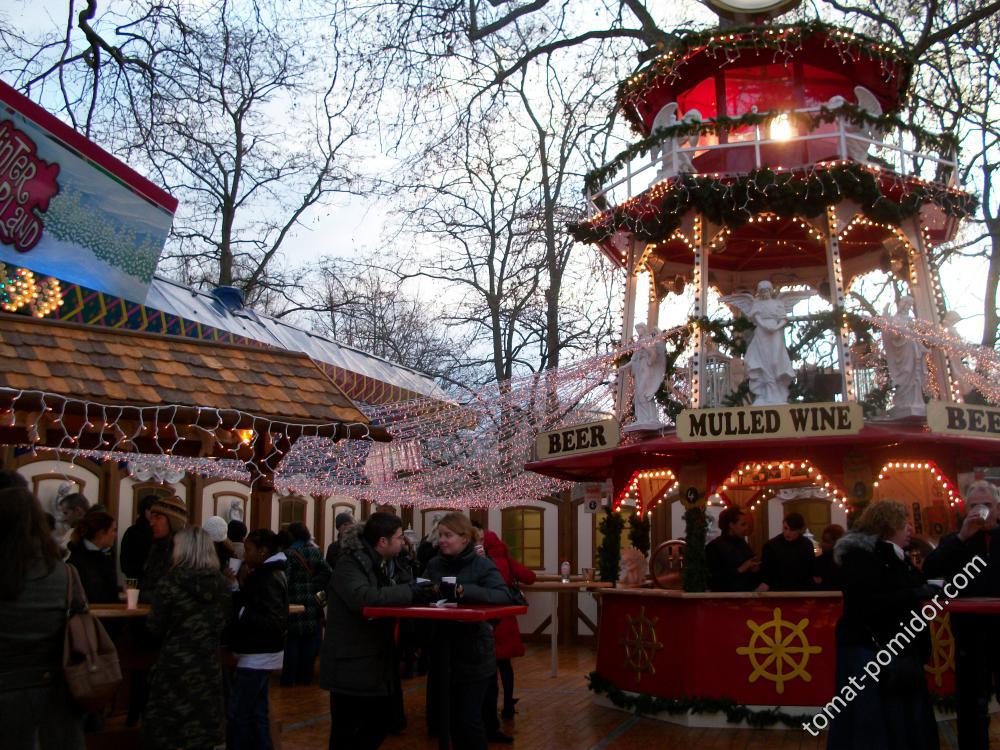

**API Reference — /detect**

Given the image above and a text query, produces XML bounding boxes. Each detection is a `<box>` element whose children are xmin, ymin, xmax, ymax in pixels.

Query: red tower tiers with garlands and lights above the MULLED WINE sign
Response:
<box><xmin>572</xmin><ymin>8</ymin><xmax>975</xmax><ymax>417</ymax></box>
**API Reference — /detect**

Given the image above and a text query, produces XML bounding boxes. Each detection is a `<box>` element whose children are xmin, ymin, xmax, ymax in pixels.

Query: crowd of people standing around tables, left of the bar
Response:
<box><xmin>0</xmin><ymin>471</ymin><xmax>534</xmax><ymax>750</ymax></box>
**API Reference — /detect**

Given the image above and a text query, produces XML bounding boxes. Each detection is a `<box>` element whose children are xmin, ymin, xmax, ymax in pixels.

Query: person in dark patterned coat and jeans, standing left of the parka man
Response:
<box><xmin>281</xmin><ymin>522</ymin><xmax>333</xmax><ymax>687</ymax></box>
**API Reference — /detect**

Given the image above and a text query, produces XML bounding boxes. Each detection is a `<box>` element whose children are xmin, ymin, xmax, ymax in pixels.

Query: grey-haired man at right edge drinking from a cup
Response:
<box><xmin>924</xmin><ymin>480</ymin><xmax>1000</xmax><ymax>750</ymax></box>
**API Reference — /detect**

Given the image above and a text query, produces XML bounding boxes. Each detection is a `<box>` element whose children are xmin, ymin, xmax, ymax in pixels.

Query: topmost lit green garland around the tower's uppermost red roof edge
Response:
<box><xmin>617</xmin><ymin>20</ymin><xmax>911</xmax><ymax>132</ymax></box>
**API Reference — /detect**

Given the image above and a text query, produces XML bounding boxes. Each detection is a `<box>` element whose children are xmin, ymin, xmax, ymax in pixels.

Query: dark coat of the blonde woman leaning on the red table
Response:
<box><xmin>424</xmin><ymin>544</ymin><xmax>514</xmax><ymax>684</ymax></box>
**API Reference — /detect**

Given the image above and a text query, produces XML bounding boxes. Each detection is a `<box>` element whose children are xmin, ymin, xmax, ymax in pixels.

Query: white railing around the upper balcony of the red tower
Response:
<box><xmin>587</xmin><ymin>107</ymin><xmax>958</xmax><ymax>217</ymax></box>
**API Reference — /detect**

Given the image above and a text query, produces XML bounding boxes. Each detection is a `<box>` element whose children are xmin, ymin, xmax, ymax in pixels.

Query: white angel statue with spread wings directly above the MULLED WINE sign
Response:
<box><xmin>722</xmin><ymin>279</ymin><xmax>811</xmax><ymax>406</ymax></box>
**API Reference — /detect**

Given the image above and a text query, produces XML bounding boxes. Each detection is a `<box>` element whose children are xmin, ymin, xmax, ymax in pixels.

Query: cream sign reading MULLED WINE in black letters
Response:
<box><xmin>677</xmin><ymin>402</ymin><xmax>864</xmax><ymax>443</ymax></box>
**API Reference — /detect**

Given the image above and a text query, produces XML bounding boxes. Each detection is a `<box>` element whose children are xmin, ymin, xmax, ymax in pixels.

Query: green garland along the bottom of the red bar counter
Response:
<box><xmin>587</xmin><ymin>671</ymin><xmax>958</xmax><ymax>729</ymax></box>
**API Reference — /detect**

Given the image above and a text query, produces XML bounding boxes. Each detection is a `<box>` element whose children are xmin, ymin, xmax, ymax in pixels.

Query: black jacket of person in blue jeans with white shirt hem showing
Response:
<box><xmin>226</xmin><ymin>553</ymin><xmax>288</xmax><ymax>654</ymax></box>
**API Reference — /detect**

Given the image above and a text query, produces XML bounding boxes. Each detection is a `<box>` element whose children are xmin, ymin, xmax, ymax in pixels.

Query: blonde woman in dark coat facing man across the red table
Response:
<box><xmin>424</xmin><ymin>513</ymin><xmax>515</xmax><ymax>750</ymax></box>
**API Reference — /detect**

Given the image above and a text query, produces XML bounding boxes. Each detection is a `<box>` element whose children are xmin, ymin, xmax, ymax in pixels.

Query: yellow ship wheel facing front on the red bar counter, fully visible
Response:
<box><xmin>736</xmin><ymin>607</ymin><xmax>823</xmax><ymax>694</ymax></box>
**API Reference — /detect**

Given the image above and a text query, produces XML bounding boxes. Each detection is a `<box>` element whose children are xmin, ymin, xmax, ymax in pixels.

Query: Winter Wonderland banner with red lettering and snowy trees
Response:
<box><xmin>0</xmin><ymin>82</ymin><xmax>177</xmax><ymax>302</ymax></box>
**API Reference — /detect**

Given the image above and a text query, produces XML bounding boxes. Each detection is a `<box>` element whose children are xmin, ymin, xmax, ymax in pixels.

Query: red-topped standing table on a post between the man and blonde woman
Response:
<box><xmin>361</xmin><ymin>604</ymin><xmax>528</xmax><ymax>750</ymax></box>
